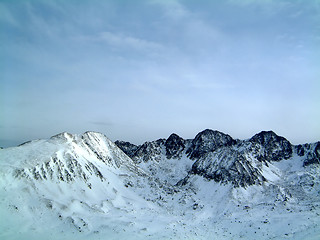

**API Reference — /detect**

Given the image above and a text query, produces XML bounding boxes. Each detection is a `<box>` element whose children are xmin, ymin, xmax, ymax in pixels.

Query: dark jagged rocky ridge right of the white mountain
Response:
<box><xmin>116</xmin><ymin>129</ymin><xmax>320</xmax><ymax>187</ymax></box>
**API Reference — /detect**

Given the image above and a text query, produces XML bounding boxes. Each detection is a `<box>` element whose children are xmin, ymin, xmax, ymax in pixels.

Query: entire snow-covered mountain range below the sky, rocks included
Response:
<box><xmin>0</xmin><ymin>129</ymin><xmax>320</xmax><ymax>239</ymax></box>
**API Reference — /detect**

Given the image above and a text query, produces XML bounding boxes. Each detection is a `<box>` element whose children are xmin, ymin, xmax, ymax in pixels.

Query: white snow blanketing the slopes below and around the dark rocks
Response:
<box><xmin>0</xmin><ymin>132</ymin><xmax>320</xmax><ymax>240</ymax></box>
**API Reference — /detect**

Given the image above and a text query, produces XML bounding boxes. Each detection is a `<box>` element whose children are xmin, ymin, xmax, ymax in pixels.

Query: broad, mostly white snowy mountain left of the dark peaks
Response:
<box><xmin>0</xmin><ymin>132</ymin><xmax>156</xmax><ymax>239</ymax></box>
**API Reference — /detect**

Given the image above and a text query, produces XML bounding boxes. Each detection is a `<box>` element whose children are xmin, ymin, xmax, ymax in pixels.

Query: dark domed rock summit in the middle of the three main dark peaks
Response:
<box><xmin>187</xmin><ymin>129</ymin><xmax>236</xmax><ymax>159</ymax></box>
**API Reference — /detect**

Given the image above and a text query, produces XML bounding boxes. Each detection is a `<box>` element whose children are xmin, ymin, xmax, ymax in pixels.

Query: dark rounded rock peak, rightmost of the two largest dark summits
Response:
<box><xmin>249</xmin><ymin>131</ymin><xmax>292</xmax><ymax>162</ymax></box>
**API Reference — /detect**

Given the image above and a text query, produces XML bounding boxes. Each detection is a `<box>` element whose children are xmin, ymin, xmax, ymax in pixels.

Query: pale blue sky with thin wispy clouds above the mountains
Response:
<box><xmin>0</xmin><ymin>0</ymin><xmax>320</xmax><ymax>147</ymax></box>
